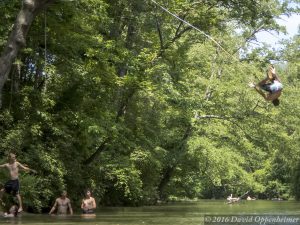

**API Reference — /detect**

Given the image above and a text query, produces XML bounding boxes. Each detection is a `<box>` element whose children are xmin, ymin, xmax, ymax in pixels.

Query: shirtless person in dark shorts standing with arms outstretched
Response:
<box><xmin>0</xmin><ymin>153</ymin><xmax>36</xmax><ymax>212</ymax></box>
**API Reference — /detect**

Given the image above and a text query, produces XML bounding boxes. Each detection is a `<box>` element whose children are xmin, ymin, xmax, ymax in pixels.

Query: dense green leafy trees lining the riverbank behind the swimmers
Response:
<box><xmin>0</xmin><ymin>0</ymin><xmax>300</xmax><ymax>211</ymax></box>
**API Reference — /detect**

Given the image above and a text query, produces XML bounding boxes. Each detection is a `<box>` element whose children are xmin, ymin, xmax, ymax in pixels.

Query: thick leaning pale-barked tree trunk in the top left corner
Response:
<box><xmin>0</xmin><ymin>0</ymin><xmax>55</xmax><ymax>108</ymax></box>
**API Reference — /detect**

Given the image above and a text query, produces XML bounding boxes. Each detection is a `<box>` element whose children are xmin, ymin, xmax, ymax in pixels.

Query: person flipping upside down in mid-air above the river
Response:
<box><xmin>249</xmin><ymin>66</ymin><xmax>283</xmax><ymax>106</ymax></box>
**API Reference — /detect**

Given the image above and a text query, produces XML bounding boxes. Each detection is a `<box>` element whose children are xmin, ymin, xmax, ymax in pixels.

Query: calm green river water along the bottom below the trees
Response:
<box><xmin>0</xmin><ymin>200</ymin><xmax>300</xmax><ymax>225</ymax></box>
